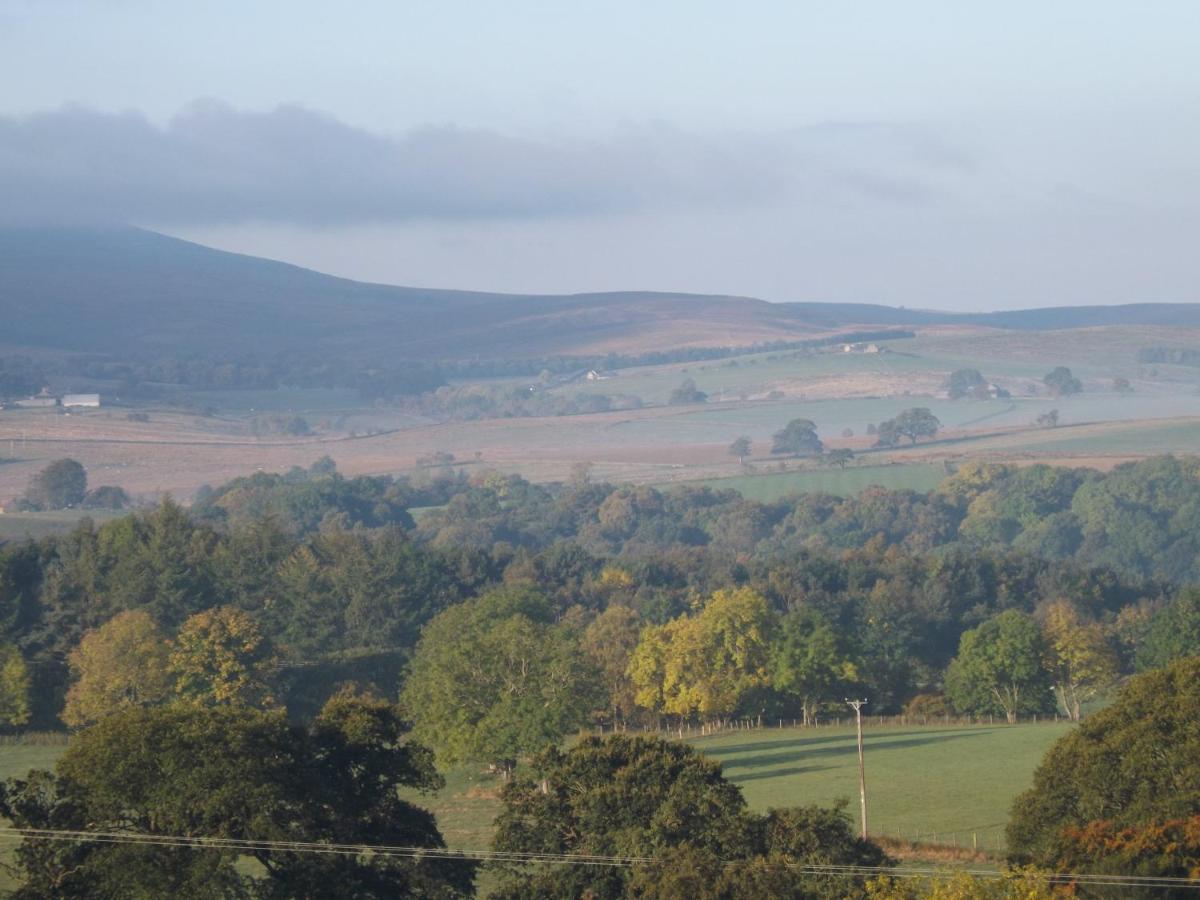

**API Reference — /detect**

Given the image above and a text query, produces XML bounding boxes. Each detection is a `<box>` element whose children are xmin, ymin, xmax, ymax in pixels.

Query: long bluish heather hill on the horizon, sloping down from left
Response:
<box><xmin>0</xmin><ymin>228</ymin><xmax>1200</xmax><ymax>360</ymax></box>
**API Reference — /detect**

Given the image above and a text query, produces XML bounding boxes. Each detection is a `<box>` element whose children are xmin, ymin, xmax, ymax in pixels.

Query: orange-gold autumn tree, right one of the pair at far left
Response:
<box><xmin>169</xmin><ymin>606</ymin><xmax>277</xmax><ymax>708</ymax></box>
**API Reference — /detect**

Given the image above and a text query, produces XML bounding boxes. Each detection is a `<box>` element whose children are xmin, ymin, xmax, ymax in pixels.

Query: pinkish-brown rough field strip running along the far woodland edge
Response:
<box><xmin>0</xmin><ymin>401</ymin><xmax>1200</xmax><ymax>504</ymax></box>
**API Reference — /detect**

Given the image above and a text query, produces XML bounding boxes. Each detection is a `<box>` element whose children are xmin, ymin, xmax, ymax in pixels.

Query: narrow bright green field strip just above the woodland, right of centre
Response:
<box><xmin>695</xmin><ymin>463</ymin><xmax>947</xmax><ymax>503</ymax></box>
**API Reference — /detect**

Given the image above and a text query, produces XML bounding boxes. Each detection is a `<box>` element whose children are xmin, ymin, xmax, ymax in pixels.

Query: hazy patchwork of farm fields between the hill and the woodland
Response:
<box><xmin>0</xmin><ymin>328</ymin><xmax>1200</xmax><ymax>513</ymax></box>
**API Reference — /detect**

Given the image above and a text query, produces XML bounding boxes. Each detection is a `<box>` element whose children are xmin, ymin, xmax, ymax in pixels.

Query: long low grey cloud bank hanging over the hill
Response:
<box><xmin>0</xmin><ymin>102</ymin><xmax>972</xmax><ymax>224</ymax></box>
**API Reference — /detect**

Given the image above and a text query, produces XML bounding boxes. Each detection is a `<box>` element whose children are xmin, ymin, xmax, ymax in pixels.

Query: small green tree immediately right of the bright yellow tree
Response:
<box><xmin>770</xmin><ymin>607</ymin><xmax>854</xmax><ymax>725</ymax></box>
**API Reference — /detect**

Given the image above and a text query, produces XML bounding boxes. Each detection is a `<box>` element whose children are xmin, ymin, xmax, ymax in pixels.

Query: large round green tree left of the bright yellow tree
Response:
<box><xmin>401</xmin><ymin>588</ymin><xmax>605</xmax><ymax>778</ymax></box>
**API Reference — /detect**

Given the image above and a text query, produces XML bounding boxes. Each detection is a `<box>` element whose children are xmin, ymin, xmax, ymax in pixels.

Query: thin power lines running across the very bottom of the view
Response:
<box><xmin>0</xmin><ymin>827</ymin><xmax>1200</xmax><ymax>890</ymax></box>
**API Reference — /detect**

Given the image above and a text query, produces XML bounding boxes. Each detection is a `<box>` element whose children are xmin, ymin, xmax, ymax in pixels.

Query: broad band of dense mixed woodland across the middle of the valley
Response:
<box><xmin>0</xmin><ymin>457</ymin><xmax>1200</xmax><ymax>725</ymax></box>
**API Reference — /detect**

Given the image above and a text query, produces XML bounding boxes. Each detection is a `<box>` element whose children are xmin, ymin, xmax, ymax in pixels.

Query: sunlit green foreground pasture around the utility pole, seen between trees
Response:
<box><xmin>0</xmin><ymin>722</ymin><xmax>1070</xmax><ymax>868</ymax></box>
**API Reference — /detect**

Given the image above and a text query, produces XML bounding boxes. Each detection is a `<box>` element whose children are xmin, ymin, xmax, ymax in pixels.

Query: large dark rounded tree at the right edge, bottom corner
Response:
<box><xmin>1008</xmin><ymin>658</ymin><xmax>1200</xmax><ymax>895</ymax></box>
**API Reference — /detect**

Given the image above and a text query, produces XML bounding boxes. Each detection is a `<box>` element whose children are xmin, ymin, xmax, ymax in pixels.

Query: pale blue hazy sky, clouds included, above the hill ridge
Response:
<box><xmin>0</xmin><ymin>0</ymin><xmax>1200</xmax><ymax>310</ymax></box>
